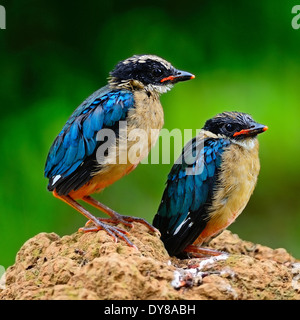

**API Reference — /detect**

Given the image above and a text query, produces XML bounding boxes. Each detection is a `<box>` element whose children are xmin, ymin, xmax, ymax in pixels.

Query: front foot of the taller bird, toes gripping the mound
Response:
<box><xmin>78</xmin><ymin>218</ymin><xmax>138</xmax><ymax>250</ymax></box>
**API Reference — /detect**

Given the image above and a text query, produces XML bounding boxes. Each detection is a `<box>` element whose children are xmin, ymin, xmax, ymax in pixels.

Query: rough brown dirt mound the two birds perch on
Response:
<box><xmin>0</xmin><ymin>224</ymin><xmax>300</xmax><ymax>300</ymax></box>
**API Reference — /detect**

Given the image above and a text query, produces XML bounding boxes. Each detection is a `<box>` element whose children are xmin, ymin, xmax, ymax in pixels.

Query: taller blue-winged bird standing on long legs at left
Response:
<box><xmin>44</xmin><ymin>54</ymin><xmax>195</xmax><ymax>247</ymax></box>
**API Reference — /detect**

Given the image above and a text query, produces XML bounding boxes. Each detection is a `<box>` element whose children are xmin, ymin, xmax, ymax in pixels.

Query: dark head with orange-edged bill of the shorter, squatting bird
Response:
<box><xmin>203</xmin><ymin>112</ymin><xmax>268</xmax><ymax>142</ymax></box>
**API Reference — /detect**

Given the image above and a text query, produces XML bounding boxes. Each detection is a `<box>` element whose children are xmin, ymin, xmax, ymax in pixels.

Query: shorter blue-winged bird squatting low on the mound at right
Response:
<box><xmin>152</xmin><ymin>111</ymin><xmax>268</xmax><ymax>258</ymax></box>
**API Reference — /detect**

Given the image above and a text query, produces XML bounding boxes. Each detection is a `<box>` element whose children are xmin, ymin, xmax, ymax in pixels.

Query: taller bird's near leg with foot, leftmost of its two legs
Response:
<box><xmin>53</xmin><ymin>191</ymin><xmax>137</xmax><ymax>249</ymax></box>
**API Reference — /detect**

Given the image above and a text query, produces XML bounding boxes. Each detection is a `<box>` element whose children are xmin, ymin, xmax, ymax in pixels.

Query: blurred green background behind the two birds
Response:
<box><xmin>0</xmin><ymin>0</ymin><xmax>300</xmax><ymax>267</ymax></box>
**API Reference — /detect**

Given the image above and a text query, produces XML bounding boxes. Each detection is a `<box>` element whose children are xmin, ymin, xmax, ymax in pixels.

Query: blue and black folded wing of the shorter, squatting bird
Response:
<box><xmin>153</xmin><ymin>138</ymin><xmax>230</xmax><ymax>255</ymax></box>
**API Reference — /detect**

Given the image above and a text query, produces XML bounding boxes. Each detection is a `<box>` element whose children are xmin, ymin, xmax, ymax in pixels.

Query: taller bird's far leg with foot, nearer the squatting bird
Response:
<box><xmin>82</xmin><ymin>196</ymin><xmax>158</xmax><ymax>232</ymax></box>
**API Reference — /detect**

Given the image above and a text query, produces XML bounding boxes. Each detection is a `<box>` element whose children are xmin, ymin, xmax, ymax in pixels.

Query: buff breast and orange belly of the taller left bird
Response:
<box><xmin>74</xmin><ymin>90</ymin><xmax>164</xmax><ymax>198</ymax></box>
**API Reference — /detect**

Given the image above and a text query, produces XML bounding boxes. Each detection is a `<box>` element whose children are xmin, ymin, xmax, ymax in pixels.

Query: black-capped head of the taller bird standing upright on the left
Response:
<box><xmin>110</xmin><ymin>55</ymin><xmax>195</xmax><ymax>93</ymax></box>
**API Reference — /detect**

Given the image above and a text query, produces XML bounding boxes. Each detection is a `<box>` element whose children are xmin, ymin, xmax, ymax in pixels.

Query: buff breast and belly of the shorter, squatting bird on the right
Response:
<box><xmin>195</xmin><ymin>139</ymin><xmax>260</xmax><ymax>245</ymax></box>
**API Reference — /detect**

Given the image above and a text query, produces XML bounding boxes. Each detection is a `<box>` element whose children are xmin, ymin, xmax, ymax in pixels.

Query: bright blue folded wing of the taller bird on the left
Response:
<box><xmin>45</xmin><ymin>86</ymin><xmax>134</xmax><ymax>194</ymax></box>
